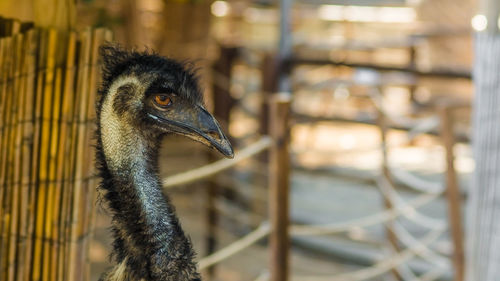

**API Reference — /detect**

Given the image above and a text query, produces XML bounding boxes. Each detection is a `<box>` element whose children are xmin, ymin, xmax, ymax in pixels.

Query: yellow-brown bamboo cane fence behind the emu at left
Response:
<box><xmin>0</xmin><ymin>18</ymin><xmax>111</xmax><ymax>281</ymax></box>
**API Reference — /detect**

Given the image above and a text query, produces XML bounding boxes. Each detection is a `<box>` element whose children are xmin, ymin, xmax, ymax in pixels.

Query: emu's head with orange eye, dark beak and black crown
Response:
<box><xmin>97</xmin><ymin>45</ymin><xmax>233</xmax><ymax>163</ymax></box>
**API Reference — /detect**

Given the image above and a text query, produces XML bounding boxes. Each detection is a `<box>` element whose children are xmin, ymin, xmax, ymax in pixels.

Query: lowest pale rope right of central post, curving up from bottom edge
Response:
<box><xmin>296</xmin><ymin>226</ymin><xmax>444</xmax><ymax>281</ymax></box>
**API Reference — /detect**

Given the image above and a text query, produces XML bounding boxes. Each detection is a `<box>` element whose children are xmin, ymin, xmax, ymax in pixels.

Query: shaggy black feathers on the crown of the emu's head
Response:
<box><xmin>99</xmin><ymin>43</ymin><xmax>203</xmax><ymax>107</ymax></box>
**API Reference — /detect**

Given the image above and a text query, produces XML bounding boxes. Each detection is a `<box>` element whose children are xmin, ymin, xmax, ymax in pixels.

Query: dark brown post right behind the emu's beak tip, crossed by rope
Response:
<box><xmin>206</xmin><ymin>43</ymin><xmax>238</xmax><ymax>278</ymax></box>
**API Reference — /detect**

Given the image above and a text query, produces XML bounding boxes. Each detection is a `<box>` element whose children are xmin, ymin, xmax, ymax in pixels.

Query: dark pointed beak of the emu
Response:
<box><xmin>150</xmin><ymin>105</ymin><xmax>234</xmax><ymax>158</ymax></box>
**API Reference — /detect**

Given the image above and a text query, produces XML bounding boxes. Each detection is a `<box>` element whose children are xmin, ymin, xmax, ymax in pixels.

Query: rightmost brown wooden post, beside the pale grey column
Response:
<box><xmin>439</xmin><ymin>106</ymin><xmax>464</xmax><ymax>281</ymax></box>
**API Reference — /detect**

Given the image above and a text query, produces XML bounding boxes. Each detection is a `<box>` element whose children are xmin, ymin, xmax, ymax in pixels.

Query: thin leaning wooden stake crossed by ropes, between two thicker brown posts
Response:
<box><xmin>377</xmin><ymin>107</ymin><xmax>403</xmax><ymax>280</ymax></box>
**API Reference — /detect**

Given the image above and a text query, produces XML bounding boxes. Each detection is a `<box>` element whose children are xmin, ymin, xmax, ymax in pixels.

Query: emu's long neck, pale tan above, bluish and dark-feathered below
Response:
<box><xmin>97</xmin><ymin>82</ymin><xmax>199</xmax><ymax>281</ymax></box>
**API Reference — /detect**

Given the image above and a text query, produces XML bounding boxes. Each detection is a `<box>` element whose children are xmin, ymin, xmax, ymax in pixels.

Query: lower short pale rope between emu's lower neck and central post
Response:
<box><xmin>199</xmin><ymin>223</ymin><xmax>271</xmax><ymax>270</ymax></box>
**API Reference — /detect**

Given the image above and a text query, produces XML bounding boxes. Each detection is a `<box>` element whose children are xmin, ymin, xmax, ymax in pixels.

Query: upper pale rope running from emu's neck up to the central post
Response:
<box><xmin>163</xmin><ymin>136</ymin><xmax>272</xmax><ymax>188</ymax></box>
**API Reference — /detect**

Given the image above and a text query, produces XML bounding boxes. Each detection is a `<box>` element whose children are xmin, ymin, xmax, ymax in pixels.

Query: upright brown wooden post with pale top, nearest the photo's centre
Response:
<box><xmin>269</xmin><ymin>93</ymin><xmax>291</xmax><ymax>281</ymax></box>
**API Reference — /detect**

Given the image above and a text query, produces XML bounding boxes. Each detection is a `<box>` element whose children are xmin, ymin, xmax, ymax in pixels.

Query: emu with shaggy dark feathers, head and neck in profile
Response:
<box><xmin>95</xmin><ymin>43</ymin><xmax>234</xmax><ymax>281</ymax></box>
